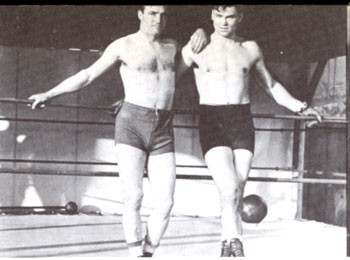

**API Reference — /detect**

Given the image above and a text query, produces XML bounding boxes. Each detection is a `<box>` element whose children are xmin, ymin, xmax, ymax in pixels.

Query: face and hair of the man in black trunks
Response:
<box><xmin>211</xmin><ymin>6</ymin><xmax>243</xmax><ymax>38</ymax></box>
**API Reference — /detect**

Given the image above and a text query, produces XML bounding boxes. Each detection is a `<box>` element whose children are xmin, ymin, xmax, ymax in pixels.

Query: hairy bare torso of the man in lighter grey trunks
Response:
<box><xmin>119</xmin><ymin>32</ymin><xmax>177</xmax><ymax>110</ymax></box>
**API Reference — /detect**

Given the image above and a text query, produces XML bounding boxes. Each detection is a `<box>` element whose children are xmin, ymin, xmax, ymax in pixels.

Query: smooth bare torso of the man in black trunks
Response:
<box><xmin>192</xmin><ymin>34</ymin><xmax>258</xmax><ymax>105</ymax></box>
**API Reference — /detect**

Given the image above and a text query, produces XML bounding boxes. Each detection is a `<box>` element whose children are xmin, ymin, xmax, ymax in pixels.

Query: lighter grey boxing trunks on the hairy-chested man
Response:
<box><xmin>115</xmin><ymin>102</ymin><xmax>174</xmax><ymax>155</ymax></box>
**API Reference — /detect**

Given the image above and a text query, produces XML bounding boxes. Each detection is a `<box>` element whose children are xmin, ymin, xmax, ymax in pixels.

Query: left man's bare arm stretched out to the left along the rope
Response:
<box><xmin>28</xmin><ymin>41</ymin><xmax>122</xmax><ymax>109</ymax></box>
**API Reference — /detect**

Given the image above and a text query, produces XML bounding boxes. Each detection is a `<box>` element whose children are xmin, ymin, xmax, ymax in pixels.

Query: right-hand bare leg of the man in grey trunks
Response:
<box><xmin>145</xmin><ymin>153</ymin><xmax>176</xmax><ymax>254</ymax></box>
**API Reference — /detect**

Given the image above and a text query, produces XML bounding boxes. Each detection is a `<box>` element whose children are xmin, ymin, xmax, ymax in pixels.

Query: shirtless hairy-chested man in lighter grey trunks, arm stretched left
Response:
<box><xmin>29</xmin><ymin>6</ymin><xmax>205</xmax><ymax>257</ymax></box>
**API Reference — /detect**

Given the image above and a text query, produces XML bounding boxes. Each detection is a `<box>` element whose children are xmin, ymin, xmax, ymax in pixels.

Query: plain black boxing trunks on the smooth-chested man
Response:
<box><xmin>199</xmin><ymin>104</ymin><xmax>255</xmax><ymax>155</ymax></box>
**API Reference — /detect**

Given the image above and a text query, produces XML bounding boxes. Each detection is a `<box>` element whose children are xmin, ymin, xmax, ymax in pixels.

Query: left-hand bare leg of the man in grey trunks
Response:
<box><xmin>116</xmin><ymin>144</ymin><xmax>146</xmax><ymax>257</ymax></box>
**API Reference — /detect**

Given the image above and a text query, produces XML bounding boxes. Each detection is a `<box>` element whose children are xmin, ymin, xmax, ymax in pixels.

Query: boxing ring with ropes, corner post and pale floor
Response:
<box><xmin>0</xmin><ymin>98</ymin><xmax>348</xmax><ymax>257</ymax></box>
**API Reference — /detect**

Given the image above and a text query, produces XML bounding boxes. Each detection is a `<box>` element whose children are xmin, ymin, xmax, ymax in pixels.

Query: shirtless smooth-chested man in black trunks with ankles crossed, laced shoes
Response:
<box><xmin>180</xmin><ymin>6</ymin><xmax>321</xmax><ymax>257</ymax></box>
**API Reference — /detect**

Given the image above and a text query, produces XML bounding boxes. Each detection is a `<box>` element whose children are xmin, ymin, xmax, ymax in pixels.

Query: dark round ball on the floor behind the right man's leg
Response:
<box><xmin>241</xmin><ymin>194</ymin><xmax>267</xmax><ymax>223</ymax></box>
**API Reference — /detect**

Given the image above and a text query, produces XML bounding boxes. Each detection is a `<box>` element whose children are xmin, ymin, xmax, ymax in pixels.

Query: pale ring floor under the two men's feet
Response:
<box><xmin>0</xmin><ymin>215</ymin><xmax>346</xmax><ymax>259</ymax></box>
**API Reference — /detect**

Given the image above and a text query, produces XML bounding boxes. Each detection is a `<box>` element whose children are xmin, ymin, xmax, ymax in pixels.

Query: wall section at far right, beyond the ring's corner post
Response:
<box><xmin>303</xmin><ymin>56</ymin><xmax>346</xmax><ymax>226</ymax></box>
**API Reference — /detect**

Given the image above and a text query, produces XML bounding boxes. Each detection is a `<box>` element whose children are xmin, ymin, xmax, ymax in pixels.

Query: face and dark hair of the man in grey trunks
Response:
<box><xmin>138</xmin><ymin>5</ymin><xmax>168</xmax><ymax>35</ymax></box>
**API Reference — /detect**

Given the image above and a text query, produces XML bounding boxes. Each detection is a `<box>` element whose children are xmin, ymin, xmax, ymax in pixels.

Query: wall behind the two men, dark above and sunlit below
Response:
<box><xmin>0</xmin><ymin>6</ymin><xmax>346</xmax><ymax>225</ymax></box>
